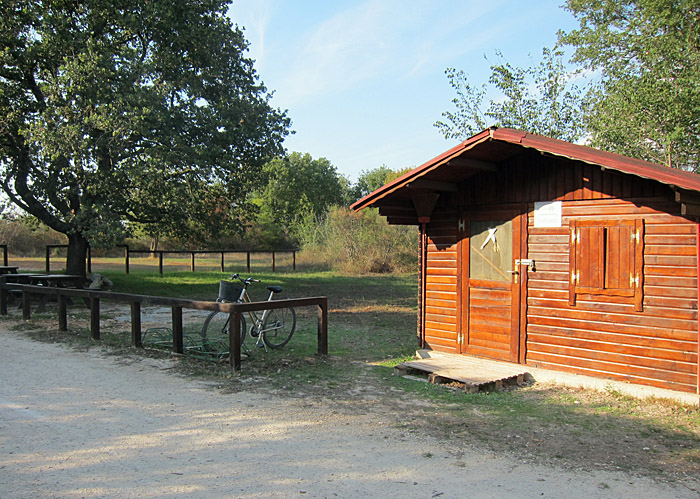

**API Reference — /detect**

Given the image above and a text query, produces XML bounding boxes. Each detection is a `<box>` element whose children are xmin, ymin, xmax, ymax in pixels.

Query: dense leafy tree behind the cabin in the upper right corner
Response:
<box><xmin>560</xmin><ymin>0</ymin><xmax>700</xmax><ymax>170</ymax></box>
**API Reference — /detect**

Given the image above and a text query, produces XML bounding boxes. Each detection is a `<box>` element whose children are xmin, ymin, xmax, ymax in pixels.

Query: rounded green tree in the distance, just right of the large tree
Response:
<box><xmin>261</xmin><ymin>152</ymin><xmax>344</xmax><ymax>228</ymax></box>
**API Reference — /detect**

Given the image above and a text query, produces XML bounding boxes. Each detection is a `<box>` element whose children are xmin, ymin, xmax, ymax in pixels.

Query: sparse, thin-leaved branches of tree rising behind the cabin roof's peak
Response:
<box><xmin>435</xmin><ymin>48</ymin><xmax>585</xmax><ymax>142</ymax></box>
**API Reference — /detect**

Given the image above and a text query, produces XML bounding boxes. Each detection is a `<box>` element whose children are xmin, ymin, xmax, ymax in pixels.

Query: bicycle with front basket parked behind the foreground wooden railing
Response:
<box><xmin>201</xmin><ymin>274</ymin><xmax>297</xmax><ymax>351</ymax></box>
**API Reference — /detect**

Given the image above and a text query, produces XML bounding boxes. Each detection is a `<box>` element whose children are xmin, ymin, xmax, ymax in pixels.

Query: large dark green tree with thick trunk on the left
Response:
<box><xmin>0</xmin><ymin>0</ymin><xmax>290</xmax><ymax>273</ymax></box>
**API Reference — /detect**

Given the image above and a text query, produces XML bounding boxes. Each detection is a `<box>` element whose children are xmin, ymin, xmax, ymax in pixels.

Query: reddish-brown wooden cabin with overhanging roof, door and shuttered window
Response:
<box><xmin>352</xmin><ymin>128</ymin><xmax>700</xmax><ymax>393</ymax></box>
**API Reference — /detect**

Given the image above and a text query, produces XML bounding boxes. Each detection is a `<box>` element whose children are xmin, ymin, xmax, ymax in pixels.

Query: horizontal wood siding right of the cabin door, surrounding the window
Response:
<box><xmin>526</xmin><ymin>197</ymin><xmax>698</xmax><ymax>392</ymax></box>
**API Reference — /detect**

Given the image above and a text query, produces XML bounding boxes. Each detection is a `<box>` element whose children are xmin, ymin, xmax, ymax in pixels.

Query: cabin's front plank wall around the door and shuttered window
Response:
<box><xmin>423</xmin><ymin>151</ymin><xmax>698</xmax><ymax>392</ymax></box>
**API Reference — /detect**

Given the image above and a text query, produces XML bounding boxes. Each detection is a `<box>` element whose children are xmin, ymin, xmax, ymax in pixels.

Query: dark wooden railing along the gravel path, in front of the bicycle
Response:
<box><xmin>0</xmin><ymin>283</ymin><xmax>328</xmax><ymax>371</ymax></box>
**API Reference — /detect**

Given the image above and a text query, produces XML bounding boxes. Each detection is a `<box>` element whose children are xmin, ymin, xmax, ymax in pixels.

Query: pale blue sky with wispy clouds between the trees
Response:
<box><xmin>229</xmin><ymin>0</ymin><xmax>577</xmax><ymax>182</ymax></box>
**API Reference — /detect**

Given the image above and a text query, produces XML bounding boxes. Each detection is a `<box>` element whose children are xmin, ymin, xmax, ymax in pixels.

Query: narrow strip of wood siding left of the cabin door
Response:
<box><xmin>424</xmin><ymin>217</ymin><xmax>458</xmax><ymax>353</ymax></box>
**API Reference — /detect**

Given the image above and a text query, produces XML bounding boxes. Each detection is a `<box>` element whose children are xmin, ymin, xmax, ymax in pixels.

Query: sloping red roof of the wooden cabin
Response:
<box><xmin>350</xmin><ymin>128</ymin><xmax>700</xmax><ymax>211</ymax></box>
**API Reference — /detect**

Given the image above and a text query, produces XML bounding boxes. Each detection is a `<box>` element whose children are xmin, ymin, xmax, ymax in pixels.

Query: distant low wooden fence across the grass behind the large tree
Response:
<box><xmin>42</xmin><ymin>244</ymin><xmax>297</xmax><ymax>274</ymax></box>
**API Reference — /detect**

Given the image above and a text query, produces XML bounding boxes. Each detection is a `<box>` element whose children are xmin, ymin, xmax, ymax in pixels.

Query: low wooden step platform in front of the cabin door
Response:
<box><xmin>394</xmin><ymin>350</ymin><xmax>532</xmax><ymax>393</ymax></box>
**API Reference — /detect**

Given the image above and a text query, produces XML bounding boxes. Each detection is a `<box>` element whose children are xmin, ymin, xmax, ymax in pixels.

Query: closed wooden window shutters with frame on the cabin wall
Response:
<box><xmin>569</xmin><ymin>219</ymin><xmax>644</xmax><ymax>312</ymax></box>
